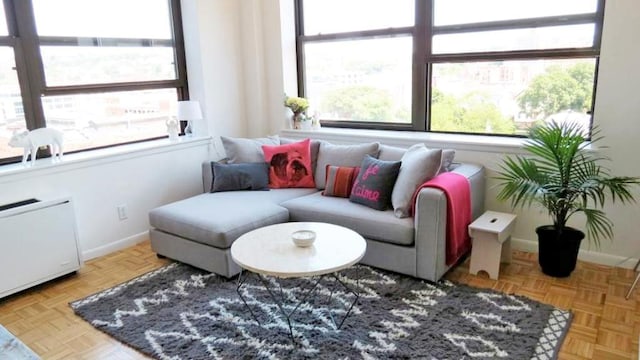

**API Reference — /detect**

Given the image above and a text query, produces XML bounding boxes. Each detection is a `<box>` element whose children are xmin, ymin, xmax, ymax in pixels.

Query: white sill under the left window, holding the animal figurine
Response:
<box><xmin>0</xmin><ymin>136</ymin><xmax>211</xmax><ymax>183</ymax></box>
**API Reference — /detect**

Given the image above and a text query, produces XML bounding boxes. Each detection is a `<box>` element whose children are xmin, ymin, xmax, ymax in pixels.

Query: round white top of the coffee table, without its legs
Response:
<box><xmin>231</xmin><ymin>222</ymin><xmax>367</xmax><ymax>278</ymax></box>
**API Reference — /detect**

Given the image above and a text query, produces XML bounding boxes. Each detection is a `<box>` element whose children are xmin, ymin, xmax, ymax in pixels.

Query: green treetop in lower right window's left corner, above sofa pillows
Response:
<box><xmin>431</xmin><ymin>89</ymin><xmax>515</xmax><ymax>134</ymax></box>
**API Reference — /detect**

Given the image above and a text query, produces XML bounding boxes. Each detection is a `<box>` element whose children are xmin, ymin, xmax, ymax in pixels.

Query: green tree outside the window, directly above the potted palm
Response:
<box><xmin>518</xmin><ymin>62</ymin><xmax>595</xmax><ymax>120</ymax></box>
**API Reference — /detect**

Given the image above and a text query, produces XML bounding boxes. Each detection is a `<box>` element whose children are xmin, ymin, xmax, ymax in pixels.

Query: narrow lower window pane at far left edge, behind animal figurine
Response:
<box><xmin>0</xmin><ymin>47</ymin><xmax>27</xmax><ymax>159</ymax></box>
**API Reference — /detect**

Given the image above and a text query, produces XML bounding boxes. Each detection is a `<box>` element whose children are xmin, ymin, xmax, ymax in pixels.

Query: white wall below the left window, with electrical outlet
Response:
<box><xmin>0</xmin><ymin>141</ymin><xmax>209</xmax><ymax>260</ymax></box>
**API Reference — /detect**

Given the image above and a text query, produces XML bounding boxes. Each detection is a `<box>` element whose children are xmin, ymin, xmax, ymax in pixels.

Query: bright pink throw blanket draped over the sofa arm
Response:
<box><xmin>412</xmin><ymin>172</ymin><xmax>471</xmax><ymax>265</ymax></box>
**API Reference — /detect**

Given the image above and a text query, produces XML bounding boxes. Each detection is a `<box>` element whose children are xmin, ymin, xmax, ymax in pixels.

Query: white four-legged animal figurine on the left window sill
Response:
<box><xmin>9</xmin><ymin>128</ymin><xmax>63</xmax><ymax>165</ymax></box>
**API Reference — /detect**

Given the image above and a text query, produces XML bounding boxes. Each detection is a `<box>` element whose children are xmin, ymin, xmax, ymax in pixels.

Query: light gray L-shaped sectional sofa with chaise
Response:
<box><xmin>149</xmin><ymin>137</ymin><xmax>485</xmax><ymax>281</ymax></box>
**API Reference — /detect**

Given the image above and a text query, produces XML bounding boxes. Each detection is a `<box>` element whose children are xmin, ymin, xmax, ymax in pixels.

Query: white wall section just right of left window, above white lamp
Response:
<box><xmin>182</xmin><ymin>0</ymin><xmax>254</xmax><ymax>156</ymax></box>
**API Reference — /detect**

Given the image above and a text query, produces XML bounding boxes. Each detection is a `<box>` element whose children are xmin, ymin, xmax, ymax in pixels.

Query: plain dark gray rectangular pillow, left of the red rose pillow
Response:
<box><xmin>211</xmin><ymin>162</ymin><xmax>269</xmax><ymax>192</ymax></box>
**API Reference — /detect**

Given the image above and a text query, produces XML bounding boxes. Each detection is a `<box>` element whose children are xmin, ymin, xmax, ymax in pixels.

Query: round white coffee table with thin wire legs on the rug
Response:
<box><xmin>231</xmin><ymin>222</ymin><xmax>367</xmax><ymax>342</ymax></box>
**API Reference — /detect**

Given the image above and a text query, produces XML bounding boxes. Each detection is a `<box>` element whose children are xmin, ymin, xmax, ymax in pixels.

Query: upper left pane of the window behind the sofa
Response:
<box><xmin>303</xmin><ymin>0</ymin><xmax>415</xmax><ymax>35</ymax></box>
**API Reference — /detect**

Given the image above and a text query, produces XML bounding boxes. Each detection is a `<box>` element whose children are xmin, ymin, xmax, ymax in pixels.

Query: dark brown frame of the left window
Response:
<box><xmin>0</xmin><ymin>0</ymin><xmax>189</xmax><ymax>165</ymax></box>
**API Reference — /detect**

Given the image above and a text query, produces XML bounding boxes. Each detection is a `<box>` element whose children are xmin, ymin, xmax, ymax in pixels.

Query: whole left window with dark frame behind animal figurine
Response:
<box><xmin>0</xmin><ymin>0</ymin><xmax>188</xmax><ymax>163</ymax></box>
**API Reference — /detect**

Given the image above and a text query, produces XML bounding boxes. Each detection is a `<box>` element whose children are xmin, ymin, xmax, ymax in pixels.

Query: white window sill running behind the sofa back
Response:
<box><xmin>280</xmin><ymin>128</ymin><xmax>526</xmax><ymax>153</ymax></box>
